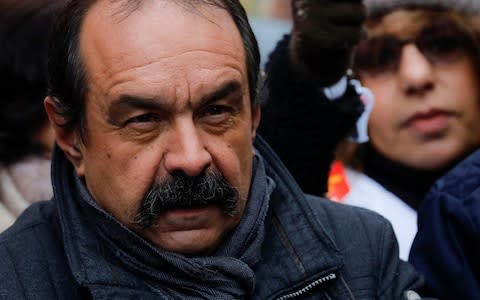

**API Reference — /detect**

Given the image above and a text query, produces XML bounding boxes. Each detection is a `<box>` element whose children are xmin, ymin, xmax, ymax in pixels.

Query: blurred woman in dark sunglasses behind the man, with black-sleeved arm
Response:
<box><xmin>260</xmin><ymin>0</ymin><xmax>480</xmax><ymax>259</ymax></box>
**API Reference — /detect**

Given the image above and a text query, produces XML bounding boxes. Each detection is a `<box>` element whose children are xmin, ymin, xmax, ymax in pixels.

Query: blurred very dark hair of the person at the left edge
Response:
<box><xmin>0</xmin><ymin>0</ymin><xmax>63</xmax><ymax>165</ymax></box>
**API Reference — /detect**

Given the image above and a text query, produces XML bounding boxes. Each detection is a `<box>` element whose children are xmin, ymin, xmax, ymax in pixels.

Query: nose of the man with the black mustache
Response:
<box><xmin>164</xmin><ymin>121</ymin><xmax>212</xmax><ymax>176</ymax></box>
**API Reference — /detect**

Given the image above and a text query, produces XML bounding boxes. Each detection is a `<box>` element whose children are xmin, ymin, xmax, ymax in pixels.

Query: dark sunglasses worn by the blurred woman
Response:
<box><xmin>353</xmin><ymin>21</ymin><xmax>474</xmax><ymax>76</ymax></box>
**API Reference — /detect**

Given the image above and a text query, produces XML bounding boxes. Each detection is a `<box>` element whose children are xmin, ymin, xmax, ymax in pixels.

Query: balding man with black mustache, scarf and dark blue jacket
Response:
<box><xmin>0</xmin><ymin>0</ymin><xmax>428</xmax><ymax>299</ymax></box>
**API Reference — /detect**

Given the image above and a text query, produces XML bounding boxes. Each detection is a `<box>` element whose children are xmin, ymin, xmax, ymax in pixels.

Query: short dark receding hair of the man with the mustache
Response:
<box><xmin>48</xmin><ymin>0</ymin><xmax>260</xmax><ymax>139</ymax></box>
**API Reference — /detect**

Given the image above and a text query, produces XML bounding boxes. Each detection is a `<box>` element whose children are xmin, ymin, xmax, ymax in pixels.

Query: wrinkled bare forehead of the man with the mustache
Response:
<box><xmin>79</xmin><ymin>0</ymin><xmax>247</xmax><ymax>103</ymax></box>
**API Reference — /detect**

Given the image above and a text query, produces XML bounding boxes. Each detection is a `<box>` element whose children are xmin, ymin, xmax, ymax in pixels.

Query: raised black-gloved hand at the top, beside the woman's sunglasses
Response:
<box><xmin>290</xmin><ymin>0</ymin><xmax>366</xmax><ymax>86</ymax></box>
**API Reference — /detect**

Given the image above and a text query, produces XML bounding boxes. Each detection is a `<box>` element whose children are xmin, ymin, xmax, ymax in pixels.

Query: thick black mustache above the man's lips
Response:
<box><xmin>133</xmin><ymin>172</ymin><xmax>239</xmax><ymax>228</ymax></box>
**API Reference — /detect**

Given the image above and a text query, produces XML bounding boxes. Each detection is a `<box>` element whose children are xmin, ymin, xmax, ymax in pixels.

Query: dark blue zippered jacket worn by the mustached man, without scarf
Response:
<box><xmin>0</xmin><ymin>138</ymin><xmax>421</xmax><ymax>300</ymax></box>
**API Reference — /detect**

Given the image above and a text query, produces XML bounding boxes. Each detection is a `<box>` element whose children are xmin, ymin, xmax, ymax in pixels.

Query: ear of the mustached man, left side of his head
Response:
<box><xmin>43</xmin><ymin>96</ymin><xmax>84</xmax><ymax>176</ymax></box>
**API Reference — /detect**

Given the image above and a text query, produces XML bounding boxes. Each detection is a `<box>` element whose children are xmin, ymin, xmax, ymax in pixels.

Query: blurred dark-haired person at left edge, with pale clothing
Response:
<box><xmin>0</xmin><ymin>0</ymin><xmax>62</xmax><ymax>231</ymax></box>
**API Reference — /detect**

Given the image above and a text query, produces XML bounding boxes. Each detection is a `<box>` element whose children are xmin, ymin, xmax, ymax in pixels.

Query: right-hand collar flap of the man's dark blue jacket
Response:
<box><xmin>255</xmin><ymin>137</ymin><xmax>343</xmax><ymax>299</ymax></box>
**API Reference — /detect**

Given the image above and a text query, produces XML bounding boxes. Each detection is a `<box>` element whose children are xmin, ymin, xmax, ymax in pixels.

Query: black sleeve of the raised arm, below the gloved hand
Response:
<box><xmin>258</xmin><ymin>36</ymin><xmax>364</xmax><ymax>196</ymax></box>
